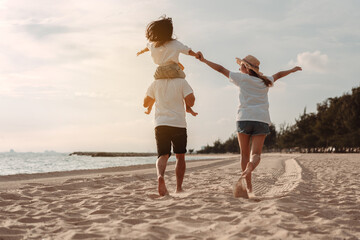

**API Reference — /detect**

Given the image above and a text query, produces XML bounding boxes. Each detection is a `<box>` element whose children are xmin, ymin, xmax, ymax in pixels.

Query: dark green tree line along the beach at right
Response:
<box><xmin>197</xmin><ymin>87</ymin><xmax>360</xmax><ymax>153</ymax></box>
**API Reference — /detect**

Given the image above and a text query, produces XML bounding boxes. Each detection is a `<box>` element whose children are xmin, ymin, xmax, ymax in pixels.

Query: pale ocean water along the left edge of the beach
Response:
<box><xmin>0</xmin><ymin>152</ymin><xmax>225</xmax><ymax>176</ymax></box>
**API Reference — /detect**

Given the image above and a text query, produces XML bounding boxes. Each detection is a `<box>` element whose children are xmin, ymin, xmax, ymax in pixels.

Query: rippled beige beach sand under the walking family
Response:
<box><xmin>0</xmin><ymin>154</ymin><xmax>360</xmax><ymax>240</ymax></box>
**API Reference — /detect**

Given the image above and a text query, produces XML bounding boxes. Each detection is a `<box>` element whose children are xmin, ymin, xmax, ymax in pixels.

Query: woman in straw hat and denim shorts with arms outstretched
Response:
<box><xmin>200</xmin><ymin>55</ymin><xmax>302</xmax><ymax>198</ymax></box>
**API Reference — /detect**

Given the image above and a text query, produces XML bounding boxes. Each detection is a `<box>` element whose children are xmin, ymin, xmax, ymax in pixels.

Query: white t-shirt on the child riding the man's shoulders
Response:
<box><xmin>147</xmin><ymin>40</ymin><xmax>191</xmax><ymax>66</ymax></box>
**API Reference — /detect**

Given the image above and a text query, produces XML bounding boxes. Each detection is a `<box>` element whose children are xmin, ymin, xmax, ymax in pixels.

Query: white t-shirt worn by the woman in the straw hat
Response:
<box><xmin>229</xmin><ymin>72</ymin><xmax>274</xmax><ymax>124</ymax></box>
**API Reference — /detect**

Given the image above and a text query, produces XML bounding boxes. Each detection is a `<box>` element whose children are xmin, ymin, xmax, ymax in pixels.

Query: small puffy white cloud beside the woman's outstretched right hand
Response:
<box><xmin>289</xmin><ymin>51</ymin><xmax>329</xmax><ymax>73</ymax></box>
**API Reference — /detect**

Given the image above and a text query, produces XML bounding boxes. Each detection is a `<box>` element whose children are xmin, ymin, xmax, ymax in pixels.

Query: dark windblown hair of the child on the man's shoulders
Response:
<box><xmin>146</xmin><ymin>16</ymin><xmax>173</xmax><ymax>47</ymax></box>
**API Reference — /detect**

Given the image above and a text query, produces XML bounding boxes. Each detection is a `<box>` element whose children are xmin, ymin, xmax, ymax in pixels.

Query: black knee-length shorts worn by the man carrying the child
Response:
<box><xmin>155</xmin><ymin>126</ymin><xmax>187</xmax><ymax>157</ymax></box>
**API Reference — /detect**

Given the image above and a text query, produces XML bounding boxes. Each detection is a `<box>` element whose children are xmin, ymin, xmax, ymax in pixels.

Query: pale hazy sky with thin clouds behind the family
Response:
<box><xmin>0</xmin><ymin>0</ymin><xmax>360</xmax><ymax>152</ymax></box>
